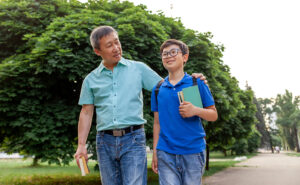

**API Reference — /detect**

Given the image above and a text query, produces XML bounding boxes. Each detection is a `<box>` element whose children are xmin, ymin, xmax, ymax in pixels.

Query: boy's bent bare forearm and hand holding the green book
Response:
<box><xmin>179</xmin><ymin>102</ymin><xmax>218</xmax><ymax>121</ymax></box>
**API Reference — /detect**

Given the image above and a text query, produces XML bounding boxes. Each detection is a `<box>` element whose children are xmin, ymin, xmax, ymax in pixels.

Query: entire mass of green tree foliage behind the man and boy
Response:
<box><xmin>0</xmin><ymin>0</ymin><xmax>255</xmax><ymax>164</ymax></box>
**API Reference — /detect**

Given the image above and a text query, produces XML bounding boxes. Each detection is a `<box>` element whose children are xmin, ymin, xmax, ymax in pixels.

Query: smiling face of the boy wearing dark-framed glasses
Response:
<box><xmin>162</xmin><ymin>44</ymin><xmax>188</xmax><ymax>72</ymax></box>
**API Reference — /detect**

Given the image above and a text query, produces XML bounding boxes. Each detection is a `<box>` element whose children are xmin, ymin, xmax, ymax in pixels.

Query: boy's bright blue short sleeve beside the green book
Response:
<box><xmin>197</xmin><ymin>78</ymin><xmax>215</xmax><ymax>108</ymax></box>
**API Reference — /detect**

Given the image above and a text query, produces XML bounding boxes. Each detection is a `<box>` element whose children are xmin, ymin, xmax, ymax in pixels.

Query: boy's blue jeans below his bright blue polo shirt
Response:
<box><xmin>157</xmin><ymin>150</ymin><xmax>205</xmax><ymax>185</ymax></box>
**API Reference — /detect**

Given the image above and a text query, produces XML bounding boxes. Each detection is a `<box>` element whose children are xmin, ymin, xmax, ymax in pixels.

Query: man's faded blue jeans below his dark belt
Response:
<box><xmin>96</xmin><ymin>128</ymin><xmax>147</xmax><ymax>185</ymax></box>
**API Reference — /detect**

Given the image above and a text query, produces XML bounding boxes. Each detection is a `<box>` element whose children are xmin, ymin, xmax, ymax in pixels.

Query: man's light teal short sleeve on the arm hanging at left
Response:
<box><xmin>78</xmin><ymin>78</ymin><xmax>94</xmax><ymax>105</ymax></box>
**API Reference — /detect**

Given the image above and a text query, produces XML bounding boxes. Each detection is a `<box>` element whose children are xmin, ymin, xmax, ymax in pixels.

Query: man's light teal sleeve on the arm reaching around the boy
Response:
<box><xmin>140</xmin><ymin>62</ymin><xmax>162</xmax><ymax>91</ymax></box>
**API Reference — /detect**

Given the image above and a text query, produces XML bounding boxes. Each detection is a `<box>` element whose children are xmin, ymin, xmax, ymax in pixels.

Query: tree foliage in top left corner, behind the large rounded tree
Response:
<box><xmin>0</xmin><ymin>0</ymin><xmax>83</xmax><ymax>63</ymax></box>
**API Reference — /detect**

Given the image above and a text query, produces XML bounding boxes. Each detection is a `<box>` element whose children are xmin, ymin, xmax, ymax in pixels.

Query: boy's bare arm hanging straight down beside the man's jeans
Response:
<box><xmin>152</xmin><ymin>112</ymin><xmax>160</xmax><ymax>173</ymax></box>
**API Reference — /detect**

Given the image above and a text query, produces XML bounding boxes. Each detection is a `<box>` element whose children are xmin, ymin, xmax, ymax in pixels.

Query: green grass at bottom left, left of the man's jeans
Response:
<box><xmin>0</xmin><ymin>159</ymin><xmax>100</xmax><ymax>185</ymax></box>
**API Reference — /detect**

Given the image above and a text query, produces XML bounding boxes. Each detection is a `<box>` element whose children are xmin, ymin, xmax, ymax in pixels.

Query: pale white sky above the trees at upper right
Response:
<box><xmin>122</xmin><ymin>0</ymin><xmax>300</xmax><ymax>98</ymax></box>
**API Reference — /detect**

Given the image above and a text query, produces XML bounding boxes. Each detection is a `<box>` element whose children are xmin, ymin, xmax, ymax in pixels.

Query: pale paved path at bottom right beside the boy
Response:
<box><xmin>202</xmin><ymin>153</ymin><xmax>300</xmax><ymax>185</ymax></box>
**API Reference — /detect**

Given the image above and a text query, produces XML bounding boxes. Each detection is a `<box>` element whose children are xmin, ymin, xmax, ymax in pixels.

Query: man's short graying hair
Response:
<box><xmin>90</xmin><ymin>26</ymin><xmax>118</xmax><ymax>49</ymax></box>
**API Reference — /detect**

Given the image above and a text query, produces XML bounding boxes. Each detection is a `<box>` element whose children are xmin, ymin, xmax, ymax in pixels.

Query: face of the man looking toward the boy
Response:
<box><xmin>94</xmin><ymin>32</ymin><xmax>122</xmax><ymax>64</ymax></box>
